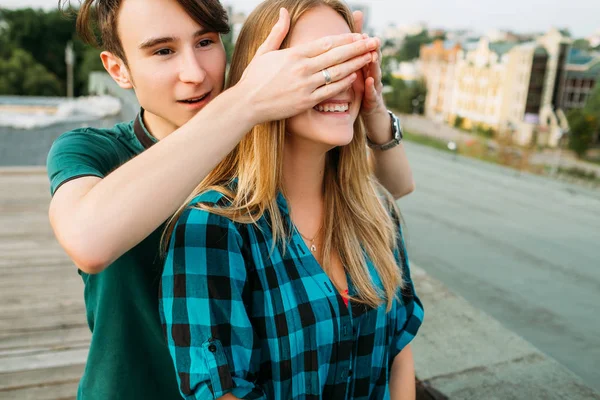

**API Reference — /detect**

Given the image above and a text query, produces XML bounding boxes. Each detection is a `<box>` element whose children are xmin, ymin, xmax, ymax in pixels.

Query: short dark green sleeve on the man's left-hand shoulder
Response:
<box><xmin>46</xmin><ymin>129</ymin><xmax>117</xmax><ymax>196</ymax></box>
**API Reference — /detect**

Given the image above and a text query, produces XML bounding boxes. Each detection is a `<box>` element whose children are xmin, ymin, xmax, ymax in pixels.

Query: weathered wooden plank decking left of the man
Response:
<box><xmin>0</xmin><ymin>168</ymin><xmax>91</xmax><ymax>400</ymax></box>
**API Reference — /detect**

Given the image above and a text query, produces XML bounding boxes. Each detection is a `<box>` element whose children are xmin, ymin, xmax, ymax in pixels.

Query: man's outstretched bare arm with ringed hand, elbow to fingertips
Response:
<box><xmin>49</xmin><ymin>13</ymin><xmax>376</xmax><ymax>273</ymax></box>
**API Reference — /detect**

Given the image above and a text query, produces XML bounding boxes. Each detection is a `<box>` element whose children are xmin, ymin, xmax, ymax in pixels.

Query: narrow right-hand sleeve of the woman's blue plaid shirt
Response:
<box><xmin>389</xmin><ymin>197</ymin><xmax>424</xmax><ymax>359</ymax></box>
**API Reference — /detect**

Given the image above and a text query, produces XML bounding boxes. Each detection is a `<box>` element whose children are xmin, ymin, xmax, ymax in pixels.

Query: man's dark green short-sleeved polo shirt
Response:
<box><xmin>47</xmin><ymin>114</ymin><xmax>181</xmax><ymax>400</ymax></box>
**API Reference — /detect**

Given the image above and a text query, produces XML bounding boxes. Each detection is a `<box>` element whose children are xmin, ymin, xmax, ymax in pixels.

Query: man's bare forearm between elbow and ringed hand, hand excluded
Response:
<box><xmin>51</xmin><ymin>88</ymin><xmax>254</xmax><ymax>272</ymax></box>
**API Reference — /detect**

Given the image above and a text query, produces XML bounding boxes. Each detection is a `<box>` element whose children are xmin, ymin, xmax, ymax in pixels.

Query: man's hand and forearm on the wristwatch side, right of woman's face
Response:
<box><xmin>354</xmin><ymin>11</ymin><xmax>415</xmax><ymax>199</ymax></box>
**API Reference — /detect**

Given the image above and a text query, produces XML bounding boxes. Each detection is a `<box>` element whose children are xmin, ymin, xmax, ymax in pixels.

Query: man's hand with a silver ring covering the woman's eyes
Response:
<box><xmin>235</xmin><ymin>9</ymin><xmax>379</xmax><ymax>124</ymax></box>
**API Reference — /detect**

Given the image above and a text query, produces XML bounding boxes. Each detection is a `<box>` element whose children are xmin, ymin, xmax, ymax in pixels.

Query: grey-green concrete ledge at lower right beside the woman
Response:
<box><xmin>411</xmin><ymin>265</ymin><xmax>600</xmax><ymax>400</ymax></box>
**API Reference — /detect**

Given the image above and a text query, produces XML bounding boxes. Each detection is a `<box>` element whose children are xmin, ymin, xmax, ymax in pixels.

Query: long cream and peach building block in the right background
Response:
<box><xmin>421</xmin><ymin>29</ymin><xmax>571</xmax><ymax>146</ymax></box>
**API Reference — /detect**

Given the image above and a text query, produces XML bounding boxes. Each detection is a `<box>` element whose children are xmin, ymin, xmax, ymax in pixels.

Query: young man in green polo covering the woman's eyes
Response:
<box><xmin>48</xmin><ymin>0</ymin><xmax>414</xmax><ymax>400</ymax></box>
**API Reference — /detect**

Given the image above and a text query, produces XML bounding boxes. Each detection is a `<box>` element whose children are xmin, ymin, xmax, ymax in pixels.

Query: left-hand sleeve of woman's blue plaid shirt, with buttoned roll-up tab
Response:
<box><xmin>160</xmin><ymin>203</ymin><xmax>266</xmax><ymax>399</ymax></box>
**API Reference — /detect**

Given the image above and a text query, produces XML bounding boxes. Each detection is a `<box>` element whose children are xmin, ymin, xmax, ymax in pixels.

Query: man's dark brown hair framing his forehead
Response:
<box><xmin>58</xmin><ymin>0</ymin><xmax>230</xmax><ymax>62</ymax></box>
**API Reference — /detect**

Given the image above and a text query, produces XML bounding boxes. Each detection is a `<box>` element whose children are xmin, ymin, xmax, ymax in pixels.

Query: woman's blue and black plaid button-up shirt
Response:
<box><xmin>160</xmin><ymin>192</ymin><xmax>423</xmax><ymax>400</ymax></box>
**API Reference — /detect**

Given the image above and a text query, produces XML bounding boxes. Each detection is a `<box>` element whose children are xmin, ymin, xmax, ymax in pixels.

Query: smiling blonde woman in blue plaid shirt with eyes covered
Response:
<box><xmin>160</xmin><ymin>0</ymin><xmax>423</xmax><ymax>400</ymax></box>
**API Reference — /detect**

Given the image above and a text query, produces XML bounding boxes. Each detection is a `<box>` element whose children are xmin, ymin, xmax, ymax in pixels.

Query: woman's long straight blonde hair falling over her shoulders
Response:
<box><xmin>163</xmin><ymin>0</ymin><xmax>402</xmax><ymax>310</ymax></box>
